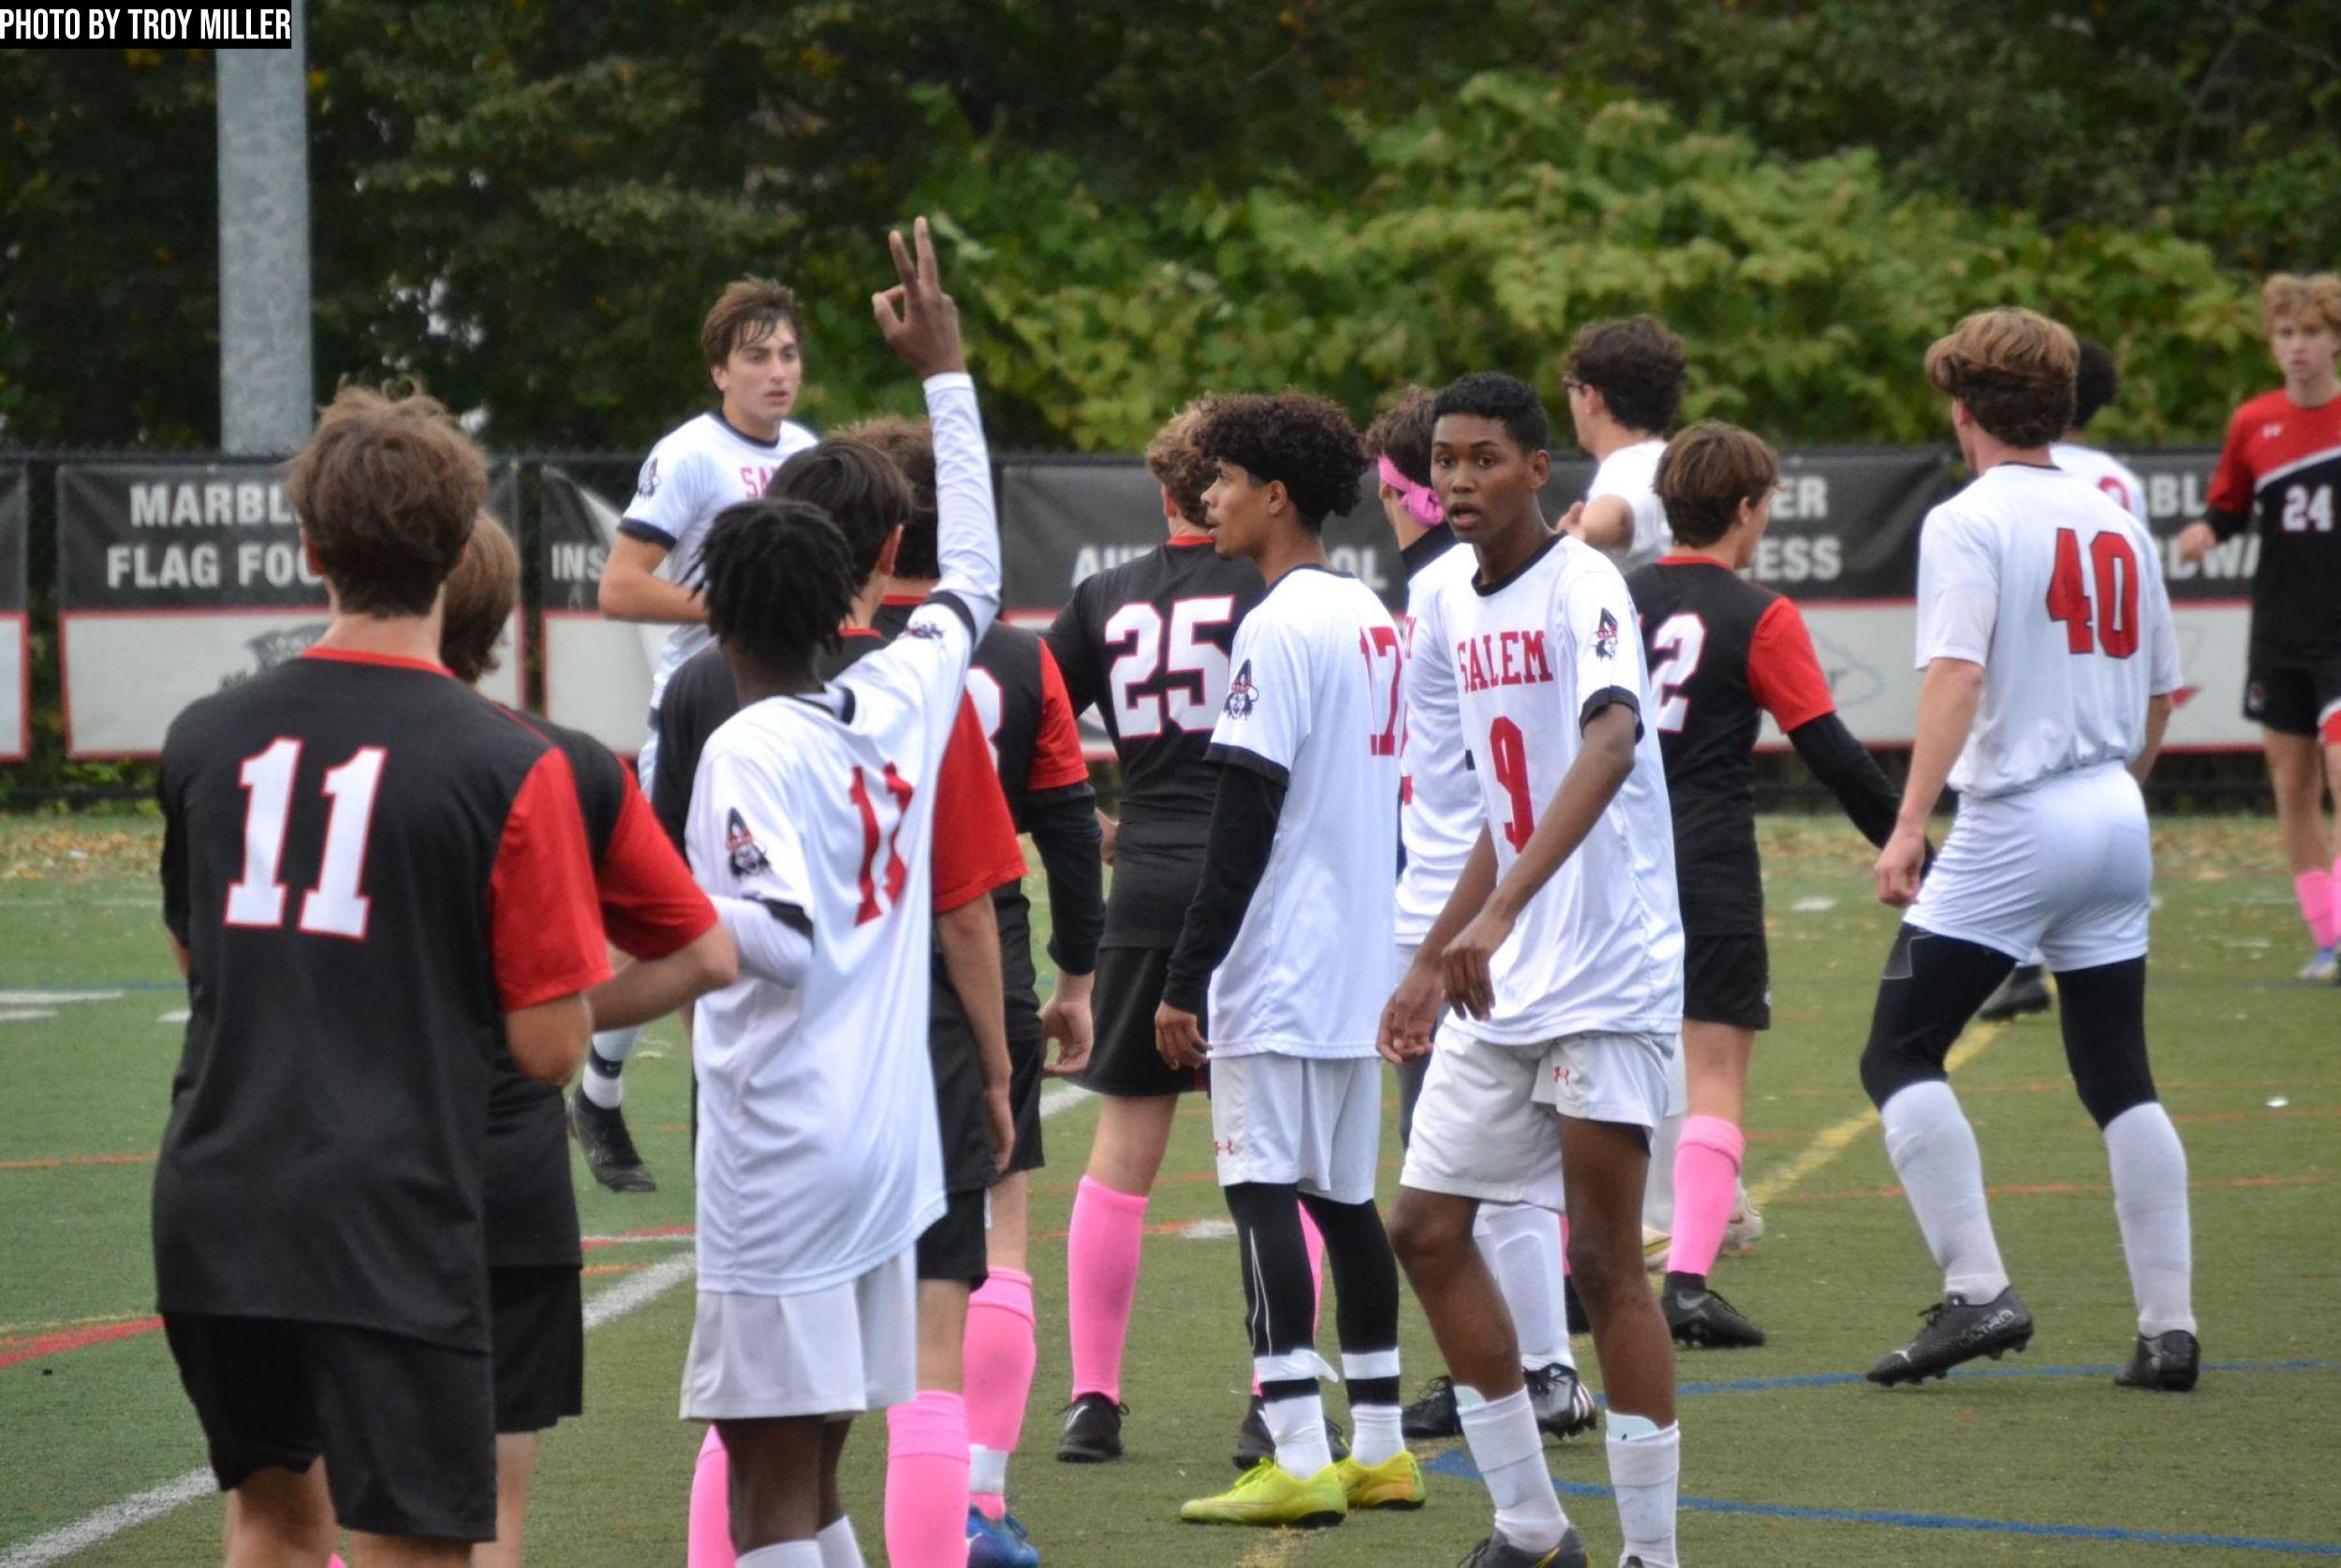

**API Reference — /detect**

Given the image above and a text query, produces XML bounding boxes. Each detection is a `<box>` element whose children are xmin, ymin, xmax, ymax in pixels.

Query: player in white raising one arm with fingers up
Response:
<box><xmin>682</xmin><ymin>223</ymin><xmax>1000</xmax><ymax>1568</ymax></box>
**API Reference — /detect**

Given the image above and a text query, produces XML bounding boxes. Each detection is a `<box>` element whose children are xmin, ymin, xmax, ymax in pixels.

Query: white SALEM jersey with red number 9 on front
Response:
<box><xmin>1417</xmin><ymin>536</ymin><xmax>1684</xmax><ymax>1047</ymax></box>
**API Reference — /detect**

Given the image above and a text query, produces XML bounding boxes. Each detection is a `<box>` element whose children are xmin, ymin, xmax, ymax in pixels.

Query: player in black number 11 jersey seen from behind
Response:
<box><xmin>155</xmin><ymin>391</ymin><xmax>609</xmax><ymax>1563</ymax></box>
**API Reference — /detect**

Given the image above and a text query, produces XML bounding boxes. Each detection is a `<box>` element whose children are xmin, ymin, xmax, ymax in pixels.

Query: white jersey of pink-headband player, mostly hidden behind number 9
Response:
<box><xmin>1398</xmin><ymin>546</ymin><xmax>1487</xmax><ymax>948</ymax></box>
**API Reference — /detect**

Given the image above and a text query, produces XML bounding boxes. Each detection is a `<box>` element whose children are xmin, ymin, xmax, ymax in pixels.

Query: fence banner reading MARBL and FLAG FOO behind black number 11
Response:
<box><xmin>56</xmin><ymin>463</ymin><xmax>524</xmax><ymax>758</ymax></box>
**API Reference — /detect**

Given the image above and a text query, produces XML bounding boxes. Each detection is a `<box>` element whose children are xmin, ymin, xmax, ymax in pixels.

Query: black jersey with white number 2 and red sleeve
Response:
<box><xmin>1627</xmin><ymin>555</ymin><xmax>1896</xmax><ymax>936</ymax></box>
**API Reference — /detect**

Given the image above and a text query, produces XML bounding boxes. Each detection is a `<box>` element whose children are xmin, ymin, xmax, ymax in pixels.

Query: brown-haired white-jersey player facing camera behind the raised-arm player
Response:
<box><xmin>569</xmin><ymin>279</ymin><xmax>813</xmax><ymax>1192</ymax></box>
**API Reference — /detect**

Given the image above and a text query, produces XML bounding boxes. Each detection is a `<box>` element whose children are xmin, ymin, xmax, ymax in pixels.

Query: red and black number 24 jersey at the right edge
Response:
<box><xmin>2203</xmin><ymin>391</ymin><xmax>2341</xmax><ymax>669</ymax></box>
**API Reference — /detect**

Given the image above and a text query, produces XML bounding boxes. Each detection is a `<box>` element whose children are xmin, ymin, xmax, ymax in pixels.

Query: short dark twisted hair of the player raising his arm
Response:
<box><xmin>700</xmin><ymin>496</ymin><xmax>869</xmax><ymax>669</ymax></box>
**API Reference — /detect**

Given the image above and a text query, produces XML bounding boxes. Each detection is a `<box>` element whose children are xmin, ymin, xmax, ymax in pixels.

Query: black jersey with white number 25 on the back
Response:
<box><xmin>1047</xmin><ymin>538</ymin><xmax>1267</xmax><ymax>950</ymax></box>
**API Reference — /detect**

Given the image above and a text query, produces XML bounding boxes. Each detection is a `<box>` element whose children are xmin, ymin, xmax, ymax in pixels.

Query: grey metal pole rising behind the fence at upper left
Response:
<box><xmin>218</xmin><ymin>0</ymin><xmax>317</xmax><ymax>457</ymax></box>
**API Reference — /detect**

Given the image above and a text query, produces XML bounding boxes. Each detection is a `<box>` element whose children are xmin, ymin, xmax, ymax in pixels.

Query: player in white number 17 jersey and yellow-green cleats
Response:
<box><xmin>1155</xmin><ymin>393</ymin><xmax>1423</xmax><ymax>1526</ymax></box>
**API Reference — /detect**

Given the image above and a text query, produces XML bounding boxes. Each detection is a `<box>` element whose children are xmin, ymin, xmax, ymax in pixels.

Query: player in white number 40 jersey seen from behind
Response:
<box><xmin>1862</xmin><ymin>309</ymin><xmax>2201</xmax><ymax>1390</ymax></box>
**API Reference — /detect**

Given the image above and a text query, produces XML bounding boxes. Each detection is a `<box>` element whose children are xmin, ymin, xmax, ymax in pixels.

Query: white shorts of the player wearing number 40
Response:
<box><xmin>1906</xmin><ymin>766</ymin><xmax>2154</xmax><ymax>972</ymax></box>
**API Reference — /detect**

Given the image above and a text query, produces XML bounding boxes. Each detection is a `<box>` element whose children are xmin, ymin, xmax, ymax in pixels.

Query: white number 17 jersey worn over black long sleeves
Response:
<box><xmin>1208</xmin><ymin>566</ymin><xmax>1405</xmax><ymax>1058</ymax></box>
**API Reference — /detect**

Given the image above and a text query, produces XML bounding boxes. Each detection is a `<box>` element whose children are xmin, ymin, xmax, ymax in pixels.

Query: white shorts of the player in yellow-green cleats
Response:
<box><xmin>1211</xmin><ymin>1053</ymin><xmax>1381</xmax><ymax>1203</ymax></box>
